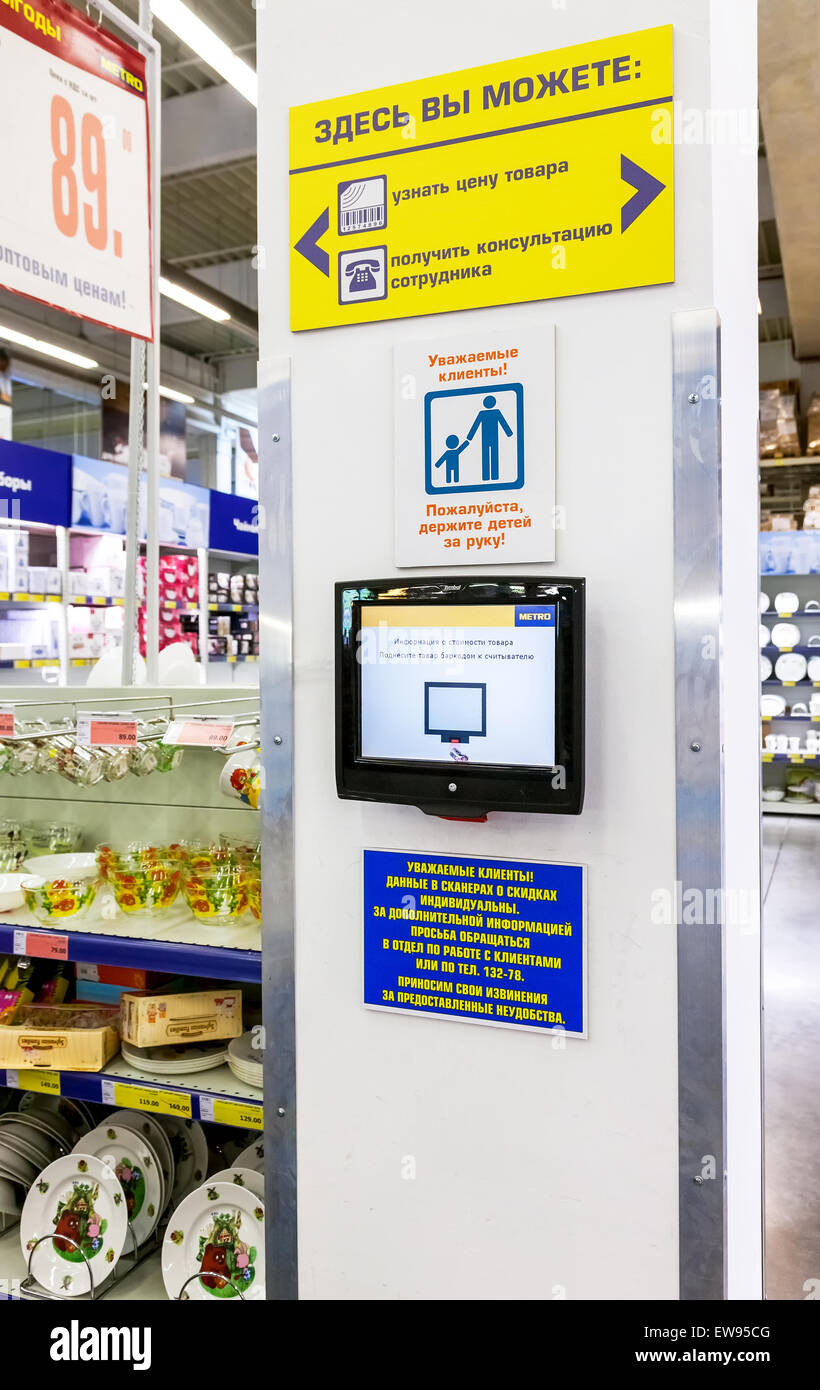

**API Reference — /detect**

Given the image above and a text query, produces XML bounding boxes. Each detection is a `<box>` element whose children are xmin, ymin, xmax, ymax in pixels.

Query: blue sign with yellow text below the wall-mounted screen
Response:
<box><xmin>364</xmin><ymin>849</ymin><xmax>587</xmax><ymax>1037</ymax></box>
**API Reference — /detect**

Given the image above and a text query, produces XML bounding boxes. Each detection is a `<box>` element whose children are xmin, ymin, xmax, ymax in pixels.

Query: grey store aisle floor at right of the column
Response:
<box><xmin>763</xmin><ymin>816</ymin><xmax>820</xmax><ymax>1298</ymax></box>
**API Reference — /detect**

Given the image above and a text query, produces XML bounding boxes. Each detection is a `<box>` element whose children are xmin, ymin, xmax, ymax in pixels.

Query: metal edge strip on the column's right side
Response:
<box><xmin>673</xmin><ymin>309</ymin><xmax>725</xmax><ymax>1300</ymax></box>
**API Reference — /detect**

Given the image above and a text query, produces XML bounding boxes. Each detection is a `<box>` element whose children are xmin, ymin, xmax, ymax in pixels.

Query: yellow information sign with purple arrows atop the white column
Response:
<box><xmin>290</xmin><ymin>25</ymin><xmax>674</xmax><ymax>329</ymax></box>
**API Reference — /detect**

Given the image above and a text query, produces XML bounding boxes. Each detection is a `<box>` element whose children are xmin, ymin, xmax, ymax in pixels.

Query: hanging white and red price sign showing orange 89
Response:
<box><xmin>0</xmin><ymin>0</ymin><xmax>153</xmax><ymax>339</ymax></box>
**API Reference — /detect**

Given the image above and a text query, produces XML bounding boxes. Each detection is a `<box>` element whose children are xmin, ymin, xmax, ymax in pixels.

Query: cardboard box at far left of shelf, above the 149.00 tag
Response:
<box><xmin>0</xmin><ymin>1004</ymin><xmax>120</xmax><ymax>1072</ymax></box>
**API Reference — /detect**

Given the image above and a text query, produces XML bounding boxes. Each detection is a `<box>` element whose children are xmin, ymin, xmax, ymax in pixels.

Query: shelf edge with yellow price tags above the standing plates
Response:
<box><xmin>0</xmin><ymin>1055</ymin><xmax>264</xmax><ymax>1130</ymax></box>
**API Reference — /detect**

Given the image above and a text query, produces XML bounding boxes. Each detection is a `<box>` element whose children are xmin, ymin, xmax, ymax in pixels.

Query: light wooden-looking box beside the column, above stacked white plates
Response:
<box><xmin>121</xmin><ymin>987</ymin><xmax>242</xmax><ymax>1047</ymax></box>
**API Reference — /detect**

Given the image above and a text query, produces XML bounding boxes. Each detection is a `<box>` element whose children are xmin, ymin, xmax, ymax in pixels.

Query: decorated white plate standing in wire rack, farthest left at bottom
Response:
<box><xmin>19</xmin><ymin>1154</ymin><xmax>128</xmax><ymax>1298</ymax></box>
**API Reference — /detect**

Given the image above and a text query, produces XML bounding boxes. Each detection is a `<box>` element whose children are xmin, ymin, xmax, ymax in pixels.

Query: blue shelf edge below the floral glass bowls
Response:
<box><xmin>0</xmin><ymin>922</ymin><xmax>261</xmax><ymax>989</ymax></box>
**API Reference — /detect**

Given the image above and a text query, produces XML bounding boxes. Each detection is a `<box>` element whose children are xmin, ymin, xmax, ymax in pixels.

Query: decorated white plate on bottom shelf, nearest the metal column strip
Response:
<box><xmin>163</xmin><ymin>1183</ymin><xmax>265</xmax><ymax>1302</ymax></box>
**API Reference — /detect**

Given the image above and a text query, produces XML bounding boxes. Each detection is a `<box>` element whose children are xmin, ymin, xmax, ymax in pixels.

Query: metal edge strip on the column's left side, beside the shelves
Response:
<box><xmin>259</xmin><ymin>359</ymin><xmax>299</xmax><ymax>1300</ymax></box>
